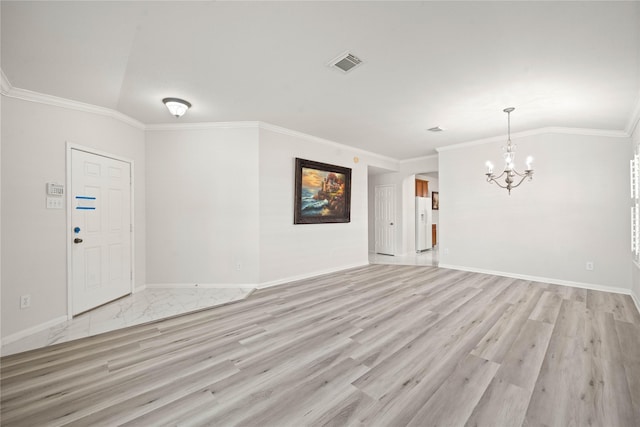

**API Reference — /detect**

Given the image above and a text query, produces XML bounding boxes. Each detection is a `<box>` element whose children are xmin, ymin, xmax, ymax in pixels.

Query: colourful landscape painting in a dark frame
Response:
<box><xmin>293</xmin><ymin>158</ymin><xmax>351</xmax><ymax>224</ymax></box>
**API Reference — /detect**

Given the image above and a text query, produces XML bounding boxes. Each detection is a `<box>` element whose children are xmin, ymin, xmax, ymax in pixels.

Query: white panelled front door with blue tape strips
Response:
<box><xmin>69</xmin><ymin>149</ymin><xmax>132</xmax><ymax>315</ymax></box>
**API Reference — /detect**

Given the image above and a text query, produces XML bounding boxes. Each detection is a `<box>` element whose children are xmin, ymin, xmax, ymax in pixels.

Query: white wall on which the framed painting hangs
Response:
<box><xmin>260</xmin><ymin>127</ymin><xmax>372</xmax><ymax>284</ymax></box>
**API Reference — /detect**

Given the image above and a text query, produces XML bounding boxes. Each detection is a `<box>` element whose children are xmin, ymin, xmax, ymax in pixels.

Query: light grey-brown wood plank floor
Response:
<box><xmin>1</xmin><ymin>265</ymin><xmax>640</xmax><ymax>427</ymax></box>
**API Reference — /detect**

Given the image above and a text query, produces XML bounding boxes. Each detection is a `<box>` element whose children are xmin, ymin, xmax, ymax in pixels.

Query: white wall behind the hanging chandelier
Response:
<box><xmin>439</xmin><ymin>133</ymin><xmax>631</xmax><ymax>289</ymax></box>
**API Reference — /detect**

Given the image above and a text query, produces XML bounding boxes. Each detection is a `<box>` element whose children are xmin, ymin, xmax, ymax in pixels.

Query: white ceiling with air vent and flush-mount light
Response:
<box><xmin>1</xmin><ymin>0</ymin><xmax>640</xmax><ymax>159</ymax></box>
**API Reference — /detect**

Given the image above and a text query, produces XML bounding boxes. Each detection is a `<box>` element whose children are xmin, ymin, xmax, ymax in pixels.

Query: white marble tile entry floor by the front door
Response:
<box><xmin>1</xmin><ymin>288</ymin><xmax>253</xmax><ymax>356</ymax></box>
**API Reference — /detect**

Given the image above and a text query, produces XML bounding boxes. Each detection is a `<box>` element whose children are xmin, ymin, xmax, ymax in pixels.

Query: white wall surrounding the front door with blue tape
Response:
<box><xmin>1</xmin><ymin>96</ymin><xmax>146</xmax><ymax>338</ymax></box>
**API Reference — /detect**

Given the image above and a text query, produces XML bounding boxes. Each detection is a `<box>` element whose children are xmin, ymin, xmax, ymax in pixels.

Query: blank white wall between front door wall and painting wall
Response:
<box><xmin>146</xmin><ymin>124</ymin><xmax>260</xmax><ymax>285</ymax></box>
